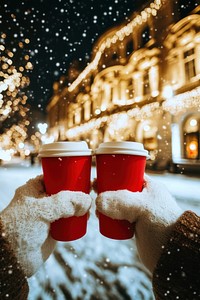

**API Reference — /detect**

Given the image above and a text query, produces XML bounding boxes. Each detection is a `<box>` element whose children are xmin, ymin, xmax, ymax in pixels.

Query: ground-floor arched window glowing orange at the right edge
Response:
<box><xmin>183</xmin><ymin>114</ymin><xmax>200</xmax><ymax>159</ymax></box>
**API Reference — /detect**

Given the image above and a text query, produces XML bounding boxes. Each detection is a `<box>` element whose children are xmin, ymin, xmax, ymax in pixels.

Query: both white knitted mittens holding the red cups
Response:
<box><xmin>0</xmin><ymin>176</ymin><xmax>182</xmax><ymax>277</ymax></box>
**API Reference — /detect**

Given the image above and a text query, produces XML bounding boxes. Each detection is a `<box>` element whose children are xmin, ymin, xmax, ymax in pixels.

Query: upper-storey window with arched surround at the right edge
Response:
<box><xmin>165</xmin><ymin>14</ymin><xmax>200</xmax><ymax>89</ymax></box>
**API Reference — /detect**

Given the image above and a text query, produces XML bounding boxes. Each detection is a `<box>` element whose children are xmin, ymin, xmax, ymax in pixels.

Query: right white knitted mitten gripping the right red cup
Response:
<box><xmin>96</xmin><ymin>176</ymin><xmax>182</xmax><ymax>272</ymax></box>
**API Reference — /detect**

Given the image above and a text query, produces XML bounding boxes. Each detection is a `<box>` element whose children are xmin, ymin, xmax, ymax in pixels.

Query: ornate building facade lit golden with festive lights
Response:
<box><xmin>47</xmin><ymin>0</ymin><xmax>200</xmax><ymax>171</ymax></box>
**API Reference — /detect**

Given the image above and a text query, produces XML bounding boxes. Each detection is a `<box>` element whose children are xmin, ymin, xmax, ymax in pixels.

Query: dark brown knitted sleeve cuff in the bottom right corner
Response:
<box><xmin>153</xmin><ymin>211</ymin><xmax>200</xmax><ymax>300</ymax></box>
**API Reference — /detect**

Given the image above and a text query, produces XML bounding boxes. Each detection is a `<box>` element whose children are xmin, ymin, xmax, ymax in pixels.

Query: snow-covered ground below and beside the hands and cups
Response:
<box><xmin>0</xmin><ymin>163</ymin><xmax>200</xmax><ymax>300</ymax></box>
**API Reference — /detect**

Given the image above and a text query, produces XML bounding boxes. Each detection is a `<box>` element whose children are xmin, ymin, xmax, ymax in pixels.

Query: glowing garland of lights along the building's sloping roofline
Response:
<box><xmin>68</xmin><ymin>0</ymin><xmax>162</xmax><ymax>92</ymax></box>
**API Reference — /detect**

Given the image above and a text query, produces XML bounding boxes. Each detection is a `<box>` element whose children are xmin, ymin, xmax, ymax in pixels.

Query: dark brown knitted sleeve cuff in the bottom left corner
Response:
<box><xmin>0</xmin><ymin>221</ymin><xmax>29</xmax><ymax>300</ymax></box>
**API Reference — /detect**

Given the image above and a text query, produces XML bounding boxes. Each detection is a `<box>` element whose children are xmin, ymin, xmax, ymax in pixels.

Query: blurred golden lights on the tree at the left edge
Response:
<box><xmin>0</xmin><ymin>33</ymin><xmax>33</xmax><ymax>155</ymax></box>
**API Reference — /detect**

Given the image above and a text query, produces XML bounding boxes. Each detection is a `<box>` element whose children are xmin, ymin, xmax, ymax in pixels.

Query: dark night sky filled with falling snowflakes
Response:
<box><xmin>0</xmin><ymin>0</ymin><xmax>145</xmax><ymax>117</ymax></box>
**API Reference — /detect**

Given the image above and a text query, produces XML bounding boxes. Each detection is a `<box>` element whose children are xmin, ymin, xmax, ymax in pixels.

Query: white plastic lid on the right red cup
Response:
<box><xmin>95</xmin><ymin>141</ymin><xmax>149</xmax><ymax>158</ymax></box>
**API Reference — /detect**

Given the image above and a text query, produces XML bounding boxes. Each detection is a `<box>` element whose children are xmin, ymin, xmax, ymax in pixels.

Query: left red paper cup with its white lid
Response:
<box><xmin>40</xmin><ymin>142</ymin><xmax>91</xmax><ymax>241</ymax></box>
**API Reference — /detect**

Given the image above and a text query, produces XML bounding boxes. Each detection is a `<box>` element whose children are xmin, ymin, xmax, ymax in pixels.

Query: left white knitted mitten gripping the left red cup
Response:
<box><xmin>0</xmin><ymin>176</ymin><xmax>91</xmax><ymax>277</ymax></box>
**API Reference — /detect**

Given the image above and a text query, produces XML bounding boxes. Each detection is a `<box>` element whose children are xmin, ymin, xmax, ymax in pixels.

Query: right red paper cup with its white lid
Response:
<box><xmin>96</xmin><ymin>142</ymin><xmax>148</xmax><ymax>240</ymax></box>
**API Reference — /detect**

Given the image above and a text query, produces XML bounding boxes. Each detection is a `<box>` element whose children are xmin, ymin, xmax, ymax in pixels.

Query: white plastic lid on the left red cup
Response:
<box><xmin>39</xmin><ymin>141</ymin><xmax>92</xmax><ymax>157</ymax></box>
